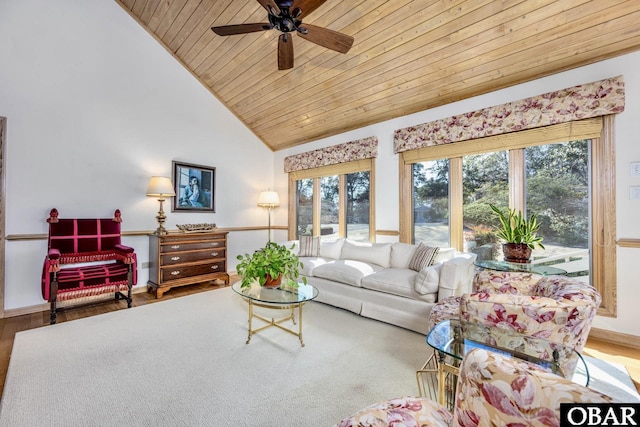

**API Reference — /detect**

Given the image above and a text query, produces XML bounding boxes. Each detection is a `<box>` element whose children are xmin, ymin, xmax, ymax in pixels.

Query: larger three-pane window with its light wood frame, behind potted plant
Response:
<box><xmin>400</xmin><ymin>117</ymin><xmax>615</xmax><ymax>315</ymax></box>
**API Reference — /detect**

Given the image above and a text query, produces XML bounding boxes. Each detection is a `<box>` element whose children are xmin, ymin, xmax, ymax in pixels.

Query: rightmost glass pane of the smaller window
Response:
<box><xmin>346</xmin><ymin>171</ymin><xmax>370</xmax><ymax>242</ymax></box>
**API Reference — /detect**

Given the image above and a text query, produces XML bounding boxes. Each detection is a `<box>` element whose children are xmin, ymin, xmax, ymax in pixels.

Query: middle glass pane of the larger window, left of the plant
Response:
<box><xmin>462</xmin><ymin>151</ymin><xmax>509</xmax><ymax>261</ymax></box>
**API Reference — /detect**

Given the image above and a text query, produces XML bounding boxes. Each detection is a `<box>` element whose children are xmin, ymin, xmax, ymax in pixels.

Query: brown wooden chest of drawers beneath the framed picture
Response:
<box><xmin>147</xmin><ymin>232</ymin><xmax>229</xmax><ymax>298</ymax></box>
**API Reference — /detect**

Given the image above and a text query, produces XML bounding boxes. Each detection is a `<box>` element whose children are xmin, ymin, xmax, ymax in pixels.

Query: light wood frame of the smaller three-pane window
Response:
<box><xmin>288</xmin><ymin>158</ymin><xmax>376</xmax><ymax>242</ymax></box>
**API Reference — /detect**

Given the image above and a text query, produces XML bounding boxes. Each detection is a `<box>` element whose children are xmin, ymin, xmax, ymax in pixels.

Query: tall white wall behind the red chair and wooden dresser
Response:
<box><xmin>0</xmin><ymin>0</ymin><xmax>273</xmax><ymax>309</ymax></box>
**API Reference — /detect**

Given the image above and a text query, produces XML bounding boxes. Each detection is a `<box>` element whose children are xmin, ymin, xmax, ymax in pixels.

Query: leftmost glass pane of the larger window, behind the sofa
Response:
<box><xmin>412</xmin><ymin>160</ymin><xmax>450</xmax><ymax>247</ymax></box>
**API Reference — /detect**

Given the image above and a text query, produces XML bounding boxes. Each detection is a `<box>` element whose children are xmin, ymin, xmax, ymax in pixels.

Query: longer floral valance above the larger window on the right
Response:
<box><xmin>394</xmin><ymin>76</ymin><xmax>625</xmax><ymax>153</ymax></box>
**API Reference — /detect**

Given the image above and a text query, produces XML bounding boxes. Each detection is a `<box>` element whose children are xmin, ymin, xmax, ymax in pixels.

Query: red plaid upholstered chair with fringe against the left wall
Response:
<box><xmin>42</xmin><ymin>209</ymin><xmax>138</xmax><ymax>324</ymax></box>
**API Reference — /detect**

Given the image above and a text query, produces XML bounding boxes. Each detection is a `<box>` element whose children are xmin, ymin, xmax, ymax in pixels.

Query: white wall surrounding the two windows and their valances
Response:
<box><xmin>275</xmin><ymin>52</ymin><xmax>640</xmax><ymax>336</ymax></box>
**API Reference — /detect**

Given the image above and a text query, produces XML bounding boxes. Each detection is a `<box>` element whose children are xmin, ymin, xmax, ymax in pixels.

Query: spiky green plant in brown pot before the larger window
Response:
<box><xmin>489</xmin><ymin>204</ymin><xmax>544</xmax><ymax>262</ymax></box>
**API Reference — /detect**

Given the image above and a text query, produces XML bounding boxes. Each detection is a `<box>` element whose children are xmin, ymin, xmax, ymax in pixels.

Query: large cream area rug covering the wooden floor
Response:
<box><xmin>0</xmin><ymin>288</ymin><xmax>630</xmax><ymax>427</ymax></box>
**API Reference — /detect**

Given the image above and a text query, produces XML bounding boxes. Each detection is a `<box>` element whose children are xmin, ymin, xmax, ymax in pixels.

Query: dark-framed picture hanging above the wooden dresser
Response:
<box><xmin>171</xmin><ymin>161</ymin><xmax>216</xmax><ymax>212</ymax></box>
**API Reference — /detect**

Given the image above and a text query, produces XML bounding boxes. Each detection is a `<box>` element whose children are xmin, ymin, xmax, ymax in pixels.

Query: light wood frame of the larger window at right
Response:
<box><xmin>399</xmin><ymin>115</ymin><xmax>617</xmax><ymax>317</ymax></box>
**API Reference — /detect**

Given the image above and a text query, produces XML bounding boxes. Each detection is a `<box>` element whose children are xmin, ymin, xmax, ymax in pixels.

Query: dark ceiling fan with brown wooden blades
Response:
<box><xmin>211</xmin><ymin>0</ymin><xmax>353</xmax><ymax>70</ymax></box>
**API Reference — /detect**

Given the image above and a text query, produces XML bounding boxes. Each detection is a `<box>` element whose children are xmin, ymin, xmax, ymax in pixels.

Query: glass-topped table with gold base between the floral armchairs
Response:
<box><xmin>416</xmin><ymin>319</ymin><xmax>589</xmax><ymax>408</ymax></box>
